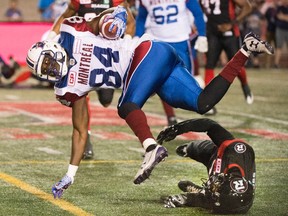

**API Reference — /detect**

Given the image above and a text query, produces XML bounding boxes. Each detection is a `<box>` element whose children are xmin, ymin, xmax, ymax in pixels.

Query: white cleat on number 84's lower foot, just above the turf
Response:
<box><xmin>134</xmin><ymin>145</ymin><xmax>168</xmax><ymax>184</ymax></box>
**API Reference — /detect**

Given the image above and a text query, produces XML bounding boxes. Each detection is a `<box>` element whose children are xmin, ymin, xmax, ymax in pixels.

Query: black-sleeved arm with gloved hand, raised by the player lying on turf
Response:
<box><xmin>157</xmin><ymin>118</ymin><xmax>234</xmax><ymax>146</ymax></box>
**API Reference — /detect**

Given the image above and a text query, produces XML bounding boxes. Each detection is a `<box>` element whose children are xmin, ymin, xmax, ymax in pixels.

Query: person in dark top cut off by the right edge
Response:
<box><xmin>274</xmin><ymin>0</ymin><xmax>288</xmax><ymax>68</ymax></box>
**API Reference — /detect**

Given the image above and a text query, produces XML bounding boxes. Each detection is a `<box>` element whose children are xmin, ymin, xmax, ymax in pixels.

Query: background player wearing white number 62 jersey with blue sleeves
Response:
<box><xmin>135</xmin><ymin>0</ymin><xmax>208</xmax><ymax>125</ymax></box>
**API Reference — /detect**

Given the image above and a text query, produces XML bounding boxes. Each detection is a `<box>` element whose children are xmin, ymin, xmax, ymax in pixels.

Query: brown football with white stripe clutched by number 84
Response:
<box><xmin>99</xmin><ymin>14</ymin><xmax>119</xmax><ymax>40</ymax></box>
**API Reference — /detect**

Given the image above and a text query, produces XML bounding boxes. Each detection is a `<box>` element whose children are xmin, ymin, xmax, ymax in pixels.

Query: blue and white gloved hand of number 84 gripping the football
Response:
<box><xmin>104</xmin><ymin>5</ymin><xmax>127</xmax><ymax>37</ymax></box>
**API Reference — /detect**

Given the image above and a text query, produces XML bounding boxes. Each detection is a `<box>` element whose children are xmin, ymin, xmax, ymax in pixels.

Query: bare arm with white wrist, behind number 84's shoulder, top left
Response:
<box><xmin>48</xmin><ymin>2</ymin><xmax>77</xmax><ymax>39</ymax></box>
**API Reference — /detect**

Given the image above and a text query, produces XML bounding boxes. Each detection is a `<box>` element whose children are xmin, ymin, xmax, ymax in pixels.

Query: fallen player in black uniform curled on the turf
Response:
<box><xmin>157</xmin><ymin>118</ymin><xmax>256</xmax><ymax>214</ymax></box>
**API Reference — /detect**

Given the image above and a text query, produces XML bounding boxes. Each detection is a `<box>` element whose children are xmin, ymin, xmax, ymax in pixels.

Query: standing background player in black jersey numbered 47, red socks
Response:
<box><xmin>200</xmin><ymin>0</ymin><xmax>254</xmax><ymax>114</ymax></box>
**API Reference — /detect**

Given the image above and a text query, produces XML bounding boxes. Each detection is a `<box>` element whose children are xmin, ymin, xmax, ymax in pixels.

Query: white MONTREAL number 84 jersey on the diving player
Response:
<box><xmin>55</xmin><ymin>17</ymin><xmax>146</xmax><ymax>96</ymax></box>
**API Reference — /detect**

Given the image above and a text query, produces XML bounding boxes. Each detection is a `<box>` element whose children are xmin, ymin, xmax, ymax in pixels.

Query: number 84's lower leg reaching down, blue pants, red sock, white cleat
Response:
<box><xmin>118</xmin><ymin>41</ymin><xmax>179</xmax><ymax>184</ymax></box>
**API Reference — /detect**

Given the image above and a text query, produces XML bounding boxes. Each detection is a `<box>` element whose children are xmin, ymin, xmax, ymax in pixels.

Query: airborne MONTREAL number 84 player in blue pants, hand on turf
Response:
<box><xmin>27</xmin><ymin>7</ymin><xmax>273</xmax><ymax>197</ymax></box>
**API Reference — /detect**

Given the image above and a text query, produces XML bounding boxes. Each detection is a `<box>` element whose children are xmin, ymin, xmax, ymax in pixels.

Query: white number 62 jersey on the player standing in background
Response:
<box><xmin>141</xmin><ymin>0</ymin><xmax>191</xmax><ymax>42</ymax></box>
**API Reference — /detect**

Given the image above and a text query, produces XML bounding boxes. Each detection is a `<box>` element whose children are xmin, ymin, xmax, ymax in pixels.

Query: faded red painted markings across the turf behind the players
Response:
<box><xmin>0</xmin><ymin>102</ymin><xmax>288</xmax><ymax>140</ymax></box>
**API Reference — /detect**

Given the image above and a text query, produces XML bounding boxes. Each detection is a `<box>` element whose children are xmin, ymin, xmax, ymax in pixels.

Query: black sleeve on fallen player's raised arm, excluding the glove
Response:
<box><xmin>178</xmin><ymin>118</ymin><xmax>234</xmax><ymax>147</ymax></box>
